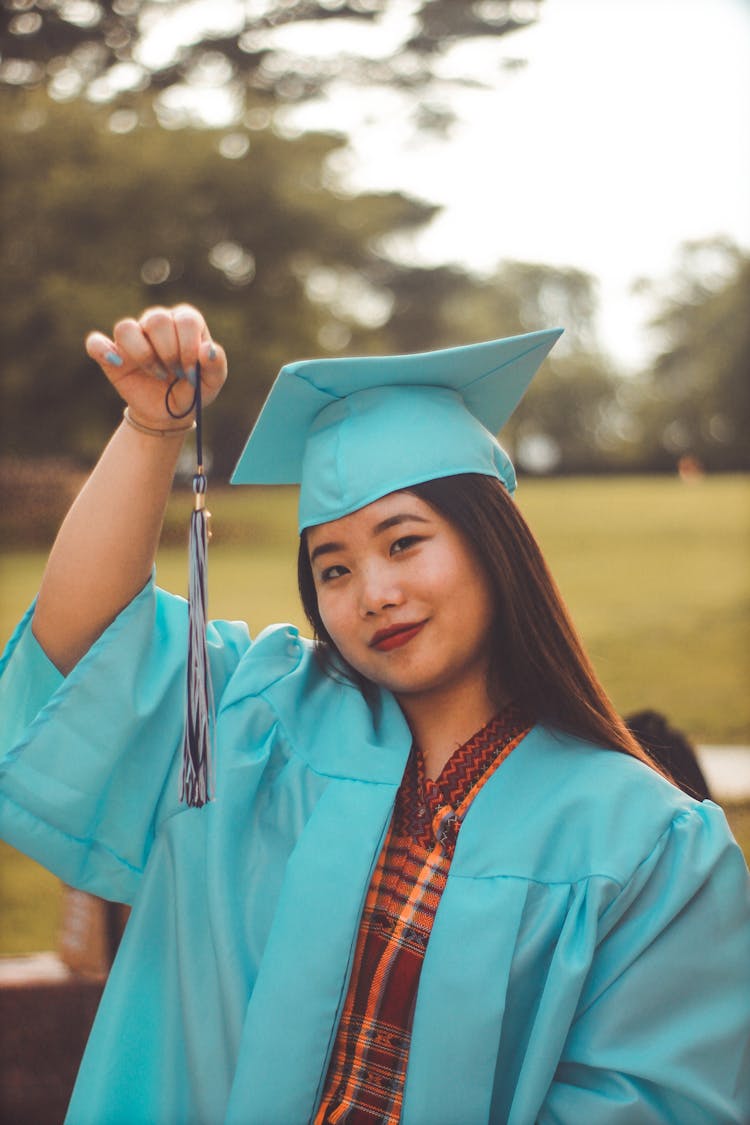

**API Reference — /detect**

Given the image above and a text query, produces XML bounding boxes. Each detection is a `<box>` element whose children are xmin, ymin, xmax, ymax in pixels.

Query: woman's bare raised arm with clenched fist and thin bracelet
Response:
<box><xmin>33</xmin><ymin>305</ymin><xmax>227</xmax><ymax>674</ymax></box>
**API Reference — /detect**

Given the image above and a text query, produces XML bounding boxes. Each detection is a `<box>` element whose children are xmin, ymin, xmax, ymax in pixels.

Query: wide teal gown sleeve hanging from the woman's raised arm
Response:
<box><xmin>0</xmin><ymin>582</ymin><xmax>250</xmax><ymax>902</ymax></box>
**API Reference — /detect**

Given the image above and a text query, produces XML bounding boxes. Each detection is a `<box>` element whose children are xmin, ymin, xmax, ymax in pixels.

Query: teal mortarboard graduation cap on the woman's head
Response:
<box><xmin>232</xmin><ymin>329</ymin><xmax>562</xmax><ymax>532</ymax></box>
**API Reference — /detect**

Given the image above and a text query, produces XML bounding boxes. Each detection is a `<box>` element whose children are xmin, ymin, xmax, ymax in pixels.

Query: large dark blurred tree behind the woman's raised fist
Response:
<box><xmin>0</xmin><ymin>93</ymin><xmax>433</xmax><ymax>473</ymax></box>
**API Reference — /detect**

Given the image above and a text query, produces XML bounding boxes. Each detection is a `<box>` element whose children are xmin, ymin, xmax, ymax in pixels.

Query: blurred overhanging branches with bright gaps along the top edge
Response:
<box><xmin>0</xmin><ymin>0</ymin><xmax>543</xmax><ymax>131</ymax></box>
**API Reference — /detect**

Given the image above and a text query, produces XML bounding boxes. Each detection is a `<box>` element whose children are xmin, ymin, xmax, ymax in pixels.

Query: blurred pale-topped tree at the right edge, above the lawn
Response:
<box><xmin>638</xmin><ymin>239</ymin><xmax>750</xmax><ymax>470</ymax></box>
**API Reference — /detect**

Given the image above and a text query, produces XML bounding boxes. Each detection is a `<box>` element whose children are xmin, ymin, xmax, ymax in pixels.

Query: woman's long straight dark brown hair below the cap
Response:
<box><xmin>297</xmin><ymin>474</ymin><xmax>654</xmax><ymax>766</ymax></box>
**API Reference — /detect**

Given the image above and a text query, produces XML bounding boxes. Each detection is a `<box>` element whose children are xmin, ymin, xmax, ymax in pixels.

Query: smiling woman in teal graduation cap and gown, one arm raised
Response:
<box><xmin>0</xmin><ymin>306</ymin><xmax>750</xmax><ymax>1125</ymax></box>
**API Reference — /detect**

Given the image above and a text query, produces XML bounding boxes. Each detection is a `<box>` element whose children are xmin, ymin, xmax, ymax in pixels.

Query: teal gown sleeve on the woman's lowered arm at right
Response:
<box><xmin>537</xmin><ymin>802</ymin><xmax>750</xmax><ymax>1125</ymax></box>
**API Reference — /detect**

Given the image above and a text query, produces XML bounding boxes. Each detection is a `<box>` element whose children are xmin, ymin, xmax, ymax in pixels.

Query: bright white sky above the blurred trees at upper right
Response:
<box><xmin>137</xmin><ymin>0</ymin><xmax>750</xmax><ymax>365</ymax></box>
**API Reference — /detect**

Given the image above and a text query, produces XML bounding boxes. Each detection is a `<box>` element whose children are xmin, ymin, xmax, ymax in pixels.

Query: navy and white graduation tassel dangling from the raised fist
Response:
<box><xmin>166</xmin><ymin>367</ymin><xmax>214</xmax><ymax>808</ymax></box>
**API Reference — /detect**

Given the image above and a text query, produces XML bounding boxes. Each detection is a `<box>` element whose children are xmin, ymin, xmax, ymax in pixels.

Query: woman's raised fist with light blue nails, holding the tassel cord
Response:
<box><xmin>85</xmin><ymin>305</ymin><xmax>227</xmax><ymax>430</ymax></box>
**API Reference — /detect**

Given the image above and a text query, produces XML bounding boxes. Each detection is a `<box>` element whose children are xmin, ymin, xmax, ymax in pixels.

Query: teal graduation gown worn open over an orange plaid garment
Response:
<box><xmin>0</xmin><ymin>584</ymin><xmax>750</xmax><ymax>1125</ymax></box>
